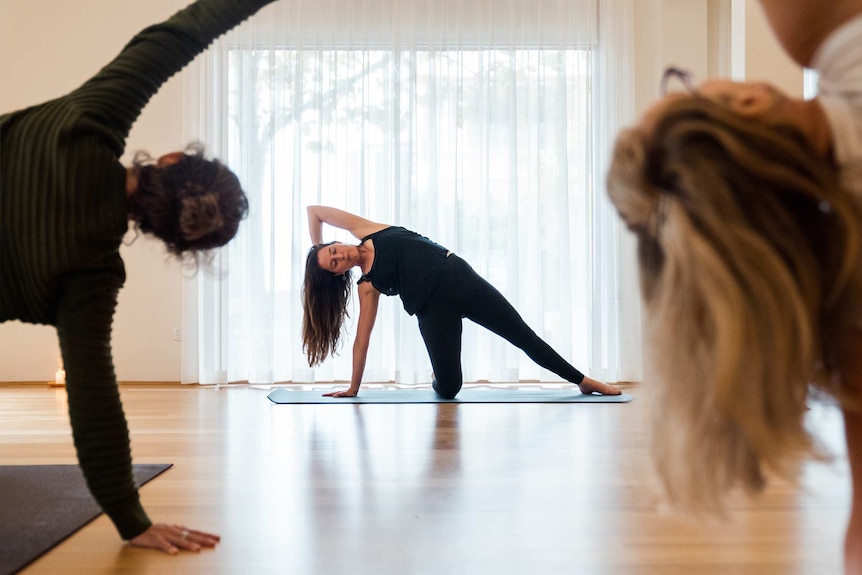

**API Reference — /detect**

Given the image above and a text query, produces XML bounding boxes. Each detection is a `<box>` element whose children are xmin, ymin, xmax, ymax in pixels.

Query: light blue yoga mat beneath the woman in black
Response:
<box><xmin>267</xmin><ymin>387</ymin><xmax>634</xmax><ymax>404</ymax></box>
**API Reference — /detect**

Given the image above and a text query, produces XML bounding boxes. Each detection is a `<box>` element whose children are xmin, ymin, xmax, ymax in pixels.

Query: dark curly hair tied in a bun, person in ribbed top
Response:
<box><xmin>128</xmin><ymin>143</ymin><xmax>248</xmax><ymax>260</ymax></box>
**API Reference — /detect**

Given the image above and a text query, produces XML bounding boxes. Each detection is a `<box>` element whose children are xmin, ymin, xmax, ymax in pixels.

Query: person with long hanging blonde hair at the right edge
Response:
<box><xmin>607</xmin><ymin>0</ymin><xmax>862</xmax><ymax>573</ymax></box>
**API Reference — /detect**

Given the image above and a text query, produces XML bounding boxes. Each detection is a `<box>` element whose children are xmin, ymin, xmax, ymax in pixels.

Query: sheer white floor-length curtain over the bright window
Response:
<box><xmin>183</xmin><ymin>0</ymin><xmax>639</xmax><ymax>383</ymax></box>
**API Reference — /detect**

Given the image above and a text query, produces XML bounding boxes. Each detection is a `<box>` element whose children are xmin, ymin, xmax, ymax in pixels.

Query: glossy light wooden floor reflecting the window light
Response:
<box><xmin>0</xmin><ymin>385</ymin><xmax>849</xmax><ymax>575</ymax></box>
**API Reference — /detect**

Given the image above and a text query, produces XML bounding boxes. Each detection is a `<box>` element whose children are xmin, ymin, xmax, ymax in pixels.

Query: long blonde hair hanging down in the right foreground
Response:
<box><xmin>607</xmin><ymin>95</ymin><xmax>860</xmax><ymax>512</ymax></box>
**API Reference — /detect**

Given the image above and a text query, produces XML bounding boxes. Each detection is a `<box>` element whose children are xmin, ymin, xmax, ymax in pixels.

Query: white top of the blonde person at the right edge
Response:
<box><xmin>811</xmin><ymin>15</ymin><xmax>862</xmax><ymax>183</ymax></box>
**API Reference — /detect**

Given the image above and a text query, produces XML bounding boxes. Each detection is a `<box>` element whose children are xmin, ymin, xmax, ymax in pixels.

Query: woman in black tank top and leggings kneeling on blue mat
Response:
<box><xmin>302</xmin><ymin>206</ymin><xmax>620</xmax><ymax>399</ymax></box>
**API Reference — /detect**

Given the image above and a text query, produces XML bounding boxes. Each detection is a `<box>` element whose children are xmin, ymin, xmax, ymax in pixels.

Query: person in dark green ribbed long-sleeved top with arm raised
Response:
<box><xmin>0</xmin><ymin>0</ymin><xmax>273</xmax><ymax>553</ymax></box>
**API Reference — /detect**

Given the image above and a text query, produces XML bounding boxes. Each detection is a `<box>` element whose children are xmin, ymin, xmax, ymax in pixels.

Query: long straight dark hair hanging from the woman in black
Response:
<box><xmin>302</xmin><ymin>242</ymin><xmax>353</xmax><ymax>367</ymax></box>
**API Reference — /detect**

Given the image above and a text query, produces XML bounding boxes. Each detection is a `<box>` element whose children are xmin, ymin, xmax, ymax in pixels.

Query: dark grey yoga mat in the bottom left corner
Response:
<box><xmin>0</xmin><ymin>463</ymin><xmax>173</xmax><ymax>575</ymax></box>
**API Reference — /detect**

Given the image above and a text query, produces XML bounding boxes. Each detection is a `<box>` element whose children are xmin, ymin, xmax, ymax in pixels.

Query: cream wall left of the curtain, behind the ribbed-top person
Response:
<box><xmin>0</xmin><ymin>0</ymin><xmax>187</xmax><ymax>381</ymax></box>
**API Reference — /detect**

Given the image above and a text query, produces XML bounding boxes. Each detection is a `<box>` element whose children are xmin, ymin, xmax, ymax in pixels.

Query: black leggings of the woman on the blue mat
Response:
<box><xmin>416</xmin><ymin>254</ymin><xmax>584</xmax><ymax>399</ymax></box>
